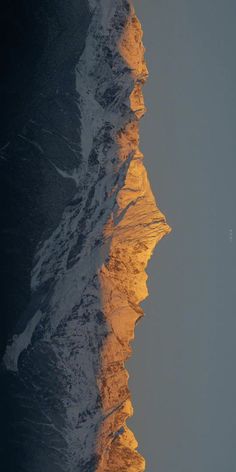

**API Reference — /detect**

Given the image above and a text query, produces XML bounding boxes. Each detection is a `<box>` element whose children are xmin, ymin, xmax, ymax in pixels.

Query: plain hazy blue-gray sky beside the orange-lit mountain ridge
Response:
<box><xmin>128</xmin><ymin>0</ymin><xmax>236</xmax><ymax>472</ymax></box>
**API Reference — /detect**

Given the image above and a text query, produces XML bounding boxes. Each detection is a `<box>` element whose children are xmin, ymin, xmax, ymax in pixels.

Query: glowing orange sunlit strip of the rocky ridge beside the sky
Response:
<box><xmin>97</xmin><ymin>4</ymin><xmax>171</xmax><ymax>472</ymax></box>
